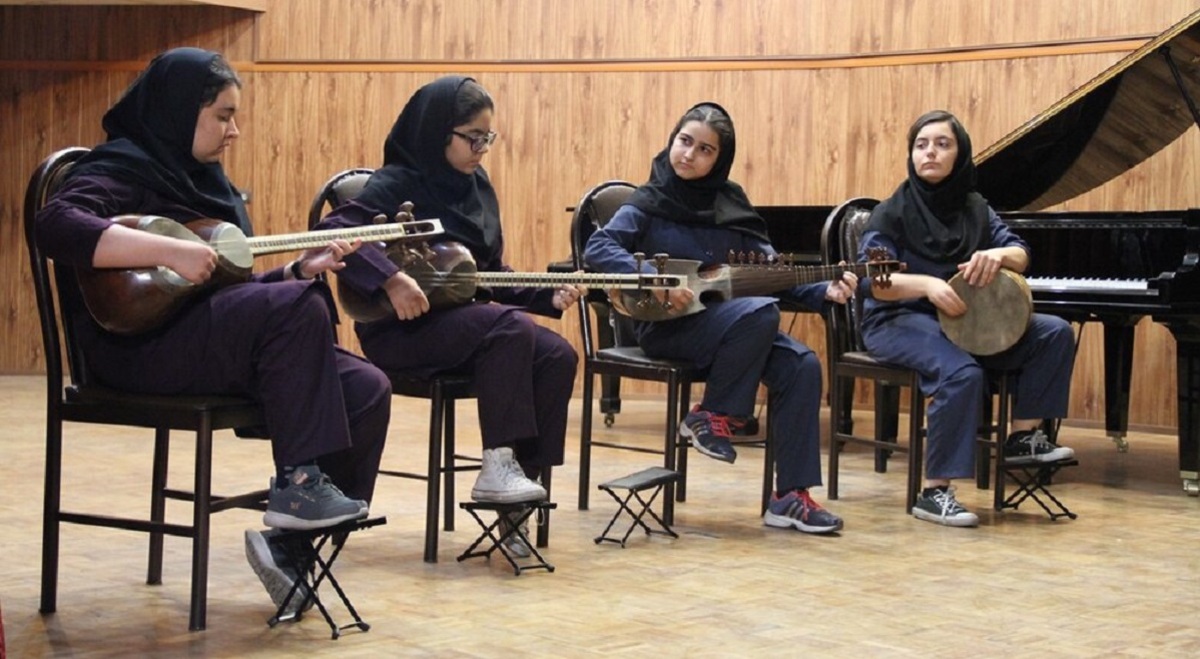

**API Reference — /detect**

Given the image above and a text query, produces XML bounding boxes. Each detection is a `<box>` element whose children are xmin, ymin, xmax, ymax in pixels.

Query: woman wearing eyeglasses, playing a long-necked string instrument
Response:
<box><xmin>320</xmin><ymin>76</ymin><xmax>581</xmax><ymax>555</ymax></box>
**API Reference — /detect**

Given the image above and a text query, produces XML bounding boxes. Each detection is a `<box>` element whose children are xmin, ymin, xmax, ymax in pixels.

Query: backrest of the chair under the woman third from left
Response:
<box><xmin>571</xmin><ymin>180</ymin><xmax>637</xmax><ymax>357</ymax></box>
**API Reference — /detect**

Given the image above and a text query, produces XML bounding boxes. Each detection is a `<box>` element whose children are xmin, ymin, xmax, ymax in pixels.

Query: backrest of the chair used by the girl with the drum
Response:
<box><xmin>821</xmin><ymin>197</ymin><xmax>880</xmax><ymax>358</ymax></box>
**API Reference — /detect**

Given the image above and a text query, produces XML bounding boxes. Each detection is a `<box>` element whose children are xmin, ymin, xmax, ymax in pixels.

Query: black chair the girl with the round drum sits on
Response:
<box><xmin>821</xmin><ymin>198</ymin><xmax>925</xmax><ymax>510</ymax></box>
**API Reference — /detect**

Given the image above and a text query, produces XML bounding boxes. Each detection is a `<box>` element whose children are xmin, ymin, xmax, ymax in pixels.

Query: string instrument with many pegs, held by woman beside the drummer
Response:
<box><xmin>610</xmin><ymin>251</ymin><xmax>905</xmax><ymax>322</ymax></box>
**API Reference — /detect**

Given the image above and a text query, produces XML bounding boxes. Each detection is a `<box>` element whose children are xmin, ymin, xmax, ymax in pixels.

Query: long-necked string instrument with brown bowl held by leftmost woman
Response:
<box><xmin>76</xmin><ymin>215</ymin><xmax>443</xmax><ymax>335</ymax></box>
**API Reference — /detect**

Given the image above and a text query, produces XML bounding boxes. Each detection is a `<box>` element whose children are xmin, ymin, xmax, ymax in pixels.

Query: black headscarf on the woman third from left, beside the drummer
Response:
<box><xmin>626</xmin><ymin>102</ymin><xmax>767</xmax><ymax>240</ymax></box>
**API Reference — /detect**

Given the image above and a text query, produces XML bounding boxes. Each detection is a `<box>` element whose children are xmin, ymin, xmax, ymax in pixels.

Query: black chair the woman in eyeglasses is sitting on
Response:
<box><xmin>308</xmin><ymin>168</ymin><xmax>551</xmax><ymax>563</ymax></box>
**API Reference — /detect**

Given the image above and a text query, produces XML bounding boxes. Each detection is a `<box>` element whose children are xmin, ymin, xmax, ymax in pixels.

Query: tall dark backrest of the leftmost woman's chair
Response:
<box><xmin>24</xmin><ymin>146</ymin><xmax>90</xmax><ymax>388</ymax></box>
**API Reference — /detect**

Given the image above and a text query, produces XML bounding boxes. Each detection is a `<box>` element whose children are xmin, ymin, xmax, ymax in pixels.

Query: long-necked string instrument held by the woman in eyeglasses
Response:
<box><xmin>337</xmin><ymin>241</ymin><xmax>688</xmax><ymax>323</ymax></box>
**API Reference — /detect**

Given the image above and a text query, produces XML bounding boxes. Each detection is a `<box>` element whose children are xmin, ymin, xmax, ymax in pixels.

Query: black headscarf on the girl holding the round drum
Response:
<box><xmin>866</xmin><ymin>112</ymin><xmax>989</xmax><ymax>263</ymax></box>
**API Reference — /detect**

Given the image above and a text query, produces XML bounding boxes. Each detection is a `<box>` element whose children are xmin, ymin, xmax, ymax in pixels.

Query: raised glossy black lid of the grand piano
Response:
<box><xmin>976</xmin><ymin>11</ymin><xmax>1200</xmax><ymax>210</ymax></box>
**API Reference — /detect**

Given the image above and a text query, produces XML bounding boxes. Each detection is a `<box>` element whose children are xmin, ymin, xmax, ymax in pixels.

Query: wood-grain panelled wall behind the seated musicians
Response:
<box><xmin>0</xmin><ymin>0</ymin><xmax>1200</xmax><ymax>427</ymax></box>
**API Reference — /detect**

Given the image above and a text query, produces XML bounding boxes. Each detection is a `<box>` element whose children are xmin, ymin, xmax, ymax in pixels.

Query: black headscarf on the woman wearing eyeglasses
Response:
<box><xmin>355</xmin><ymin>76</ymin><xmax>500</xmax><ymax>264</ymax></box>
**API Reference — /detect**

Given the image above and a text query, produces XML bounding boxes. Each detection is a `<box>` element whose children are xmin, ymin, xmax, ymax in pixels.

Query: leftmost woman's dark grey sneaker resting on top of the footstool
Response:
<box><xmin>263</xmin><ymin>465</ymin><xmax>367</xmax><ymax>531</ymax></box>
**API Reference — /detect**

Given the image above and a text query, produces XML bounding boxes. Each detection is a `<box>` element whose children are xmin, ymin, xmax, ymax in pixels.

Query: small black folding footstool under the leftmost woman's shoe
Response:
<box><xmin>266</xmin><ymin>517</ymin><xmax>388</xmax><ymax>641</ymax></box>
